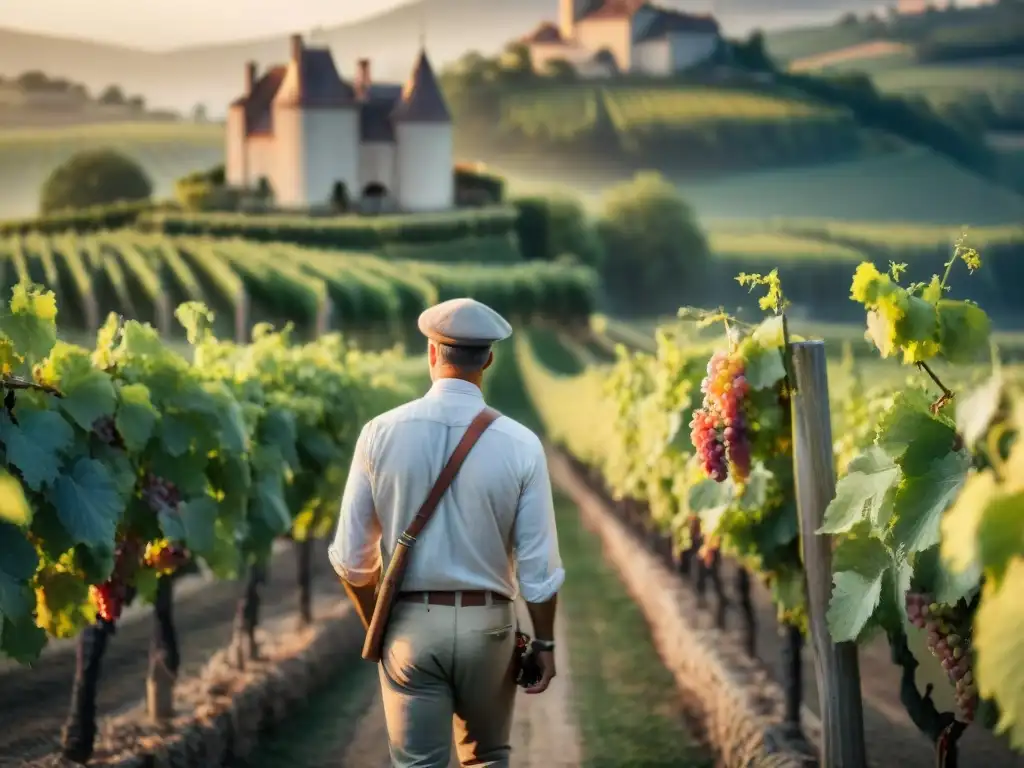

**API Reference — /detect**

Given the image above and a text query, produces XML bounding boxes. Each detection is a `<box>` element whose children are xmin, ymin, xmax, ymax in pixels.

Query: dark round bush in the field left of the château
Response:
<box><xmin>39</xmin><ymin>150</ymin><xmax>153</xmax><ymax>215</ymax></box>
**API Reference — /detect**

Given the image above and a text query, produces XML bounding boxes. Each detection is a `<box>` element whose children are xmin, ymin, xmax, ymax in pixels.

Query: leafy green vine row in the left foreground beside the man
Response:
<box><xmin>0</xmin><ymin>284</ymin><xmax>413</xmax><ymax>663</ymax></box>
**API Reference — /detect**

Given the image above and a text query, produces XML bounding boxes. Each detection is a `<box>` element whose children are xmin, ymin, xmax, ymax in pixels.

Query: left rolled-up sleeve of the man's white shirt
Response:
<box><xmin>327</xmin><ymin>424</ymin><xmax>381</xmax><ymax>587</ymax></box>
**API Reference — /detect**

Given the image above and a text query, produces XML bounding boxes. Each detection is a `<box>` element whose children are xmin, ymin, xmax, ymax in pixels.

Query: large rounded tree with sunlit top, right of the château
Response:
<box><xmin>597</xmin><ymin>173</ymin><xmax>709</xmax><ymax>312</ymax></box>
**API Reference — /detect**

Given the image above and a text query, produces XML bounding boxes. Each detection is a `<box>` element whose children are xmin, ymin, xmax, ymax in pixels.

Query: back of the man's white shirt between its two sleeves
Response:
<box><xmin>356</xmin><ymin>379</ymin><xmax>547</xmax><ymax>597</ymax></box>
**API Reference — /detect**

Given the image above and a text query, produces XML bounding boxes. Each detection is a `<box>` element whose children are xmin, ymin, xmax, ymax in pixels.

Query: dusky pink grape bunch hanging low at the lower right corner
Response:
<box><xmin>906</xmin><ymin>592</ymin><xmax>978</xmax><ymax>723</ymax></box>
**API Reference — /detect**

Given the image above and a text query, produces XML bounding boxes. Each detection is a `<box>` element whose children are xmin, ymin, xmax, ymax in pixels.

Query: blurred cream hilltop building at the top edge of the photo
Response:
<box><xmin>522</xmin><ymin>0</ymin><xmax>722</xmax><ymax>76</ymax></box>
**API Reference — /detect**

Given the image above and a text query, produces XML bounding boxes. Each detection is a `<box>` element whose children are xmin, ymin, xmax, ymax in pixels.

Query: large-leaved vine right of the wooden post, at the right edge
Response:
<box><xmin>819</xmin><ymin>246</ymin><xmax>1024</xmax><ymax>759</ymax></box>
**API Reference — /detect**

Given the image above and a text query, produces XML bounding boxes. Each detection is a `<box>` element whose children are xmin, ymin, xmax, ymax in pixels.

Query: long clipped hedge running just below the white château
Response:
<box><xmin>137</xmin><ymin>206</ymin><xmax>517</xmax><ymax>253</ymax></box>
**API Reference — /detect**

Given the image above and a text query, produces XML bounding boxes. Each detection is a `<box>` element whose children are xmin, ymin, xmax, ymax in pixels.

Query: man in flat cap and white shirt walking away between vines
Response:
<box><xmin>329</xmin><ymin>299</ymin><xmax>565</xmax><ymax>768</ymax></box>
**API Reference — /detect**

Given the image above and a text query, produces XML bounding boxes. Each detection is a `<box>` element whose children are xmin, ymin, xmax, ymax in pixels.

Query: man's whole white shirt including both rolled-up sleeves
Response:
<box><xmin>328</xmin><ymin>379</ymin><xmax>565</xmax><ymax>603</ymax></box>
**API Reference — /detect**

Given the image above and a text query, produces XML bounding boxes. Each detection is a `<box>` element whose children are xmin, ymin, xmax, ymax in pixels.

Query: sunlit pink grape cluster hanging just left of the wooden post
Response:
<box><xmin>690</xmin><ymin>352</ymin><xmax>751</xmax><ymax>482</ymax></box>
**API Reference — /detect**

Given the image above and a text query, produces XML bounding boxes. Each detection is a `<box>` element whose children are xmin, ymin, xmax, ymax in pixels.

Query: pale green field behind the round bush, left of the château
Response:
<box><xmin>0</xmin><ymin>123</ymin><xmax>224</xmax><ymax>218</ymax></box>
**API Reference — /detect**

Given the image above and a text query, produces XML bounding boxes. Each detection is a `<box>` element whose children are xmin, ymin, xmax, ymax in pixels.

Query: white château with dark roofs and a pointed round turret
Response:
<box><xmin>225</xmin><ymin>35</ymin><xmax>455</xmax><ymax>212</ymax></box>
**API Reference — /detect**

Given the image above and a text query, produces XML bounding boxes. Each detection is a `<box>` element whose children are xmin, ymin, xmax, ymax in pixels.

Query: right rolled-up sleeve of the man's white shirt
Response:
<box><xmin>513</xmin><ymin>445</ymin><xmax>565</xmax><ymax>603</ymax></box>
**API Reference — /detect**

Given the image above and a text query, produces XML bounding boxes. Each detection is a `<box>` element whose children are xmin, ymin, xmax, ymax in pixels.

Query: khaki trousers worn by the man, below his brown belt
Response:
<box><xmin>379</xmin><ymin>601</ymin><xmax>516</xmax><ymax>768</ymax></box>
